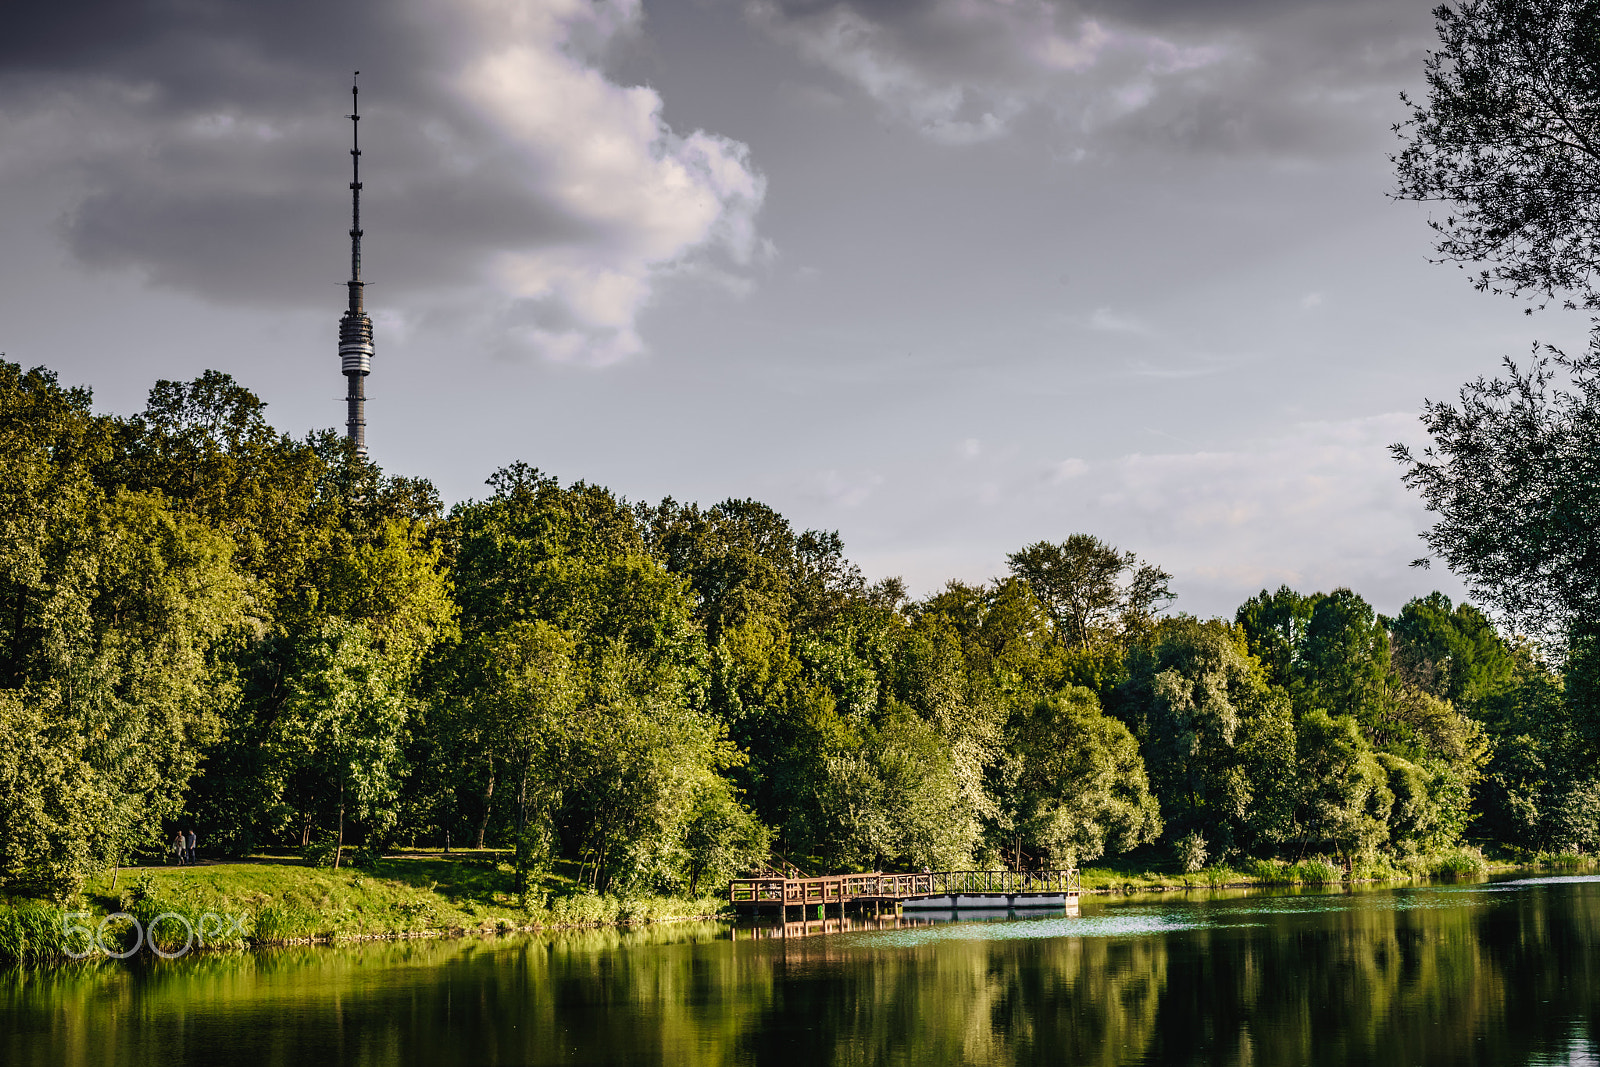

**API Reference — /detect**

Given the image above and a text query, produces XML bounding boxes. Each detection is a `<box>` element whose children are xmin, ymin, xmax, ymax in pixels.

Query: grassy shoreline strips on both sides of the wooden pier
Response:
<box><xmin>0</xmin><ymin>848</ymin><xmax>1600</xmax><ymax>966</ymax></box>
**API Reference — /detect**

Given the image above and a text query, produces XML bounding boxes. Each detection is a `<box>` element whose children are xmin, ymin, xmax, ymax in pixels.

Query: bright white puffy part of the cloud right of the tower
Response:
<box><xmin>450</xmin><ymin>0</ymin><xmax>765</xmax><ymax>363</ymax></box>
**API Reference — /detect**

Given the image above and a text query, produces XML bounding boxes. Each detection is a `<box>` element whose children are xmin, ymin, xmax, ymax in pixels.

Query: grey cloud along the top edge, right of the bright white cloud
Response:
<box><xmin>744</xmin><ymin>0</ymin><xmax>1429</xmax><ymax>155</ymax></box>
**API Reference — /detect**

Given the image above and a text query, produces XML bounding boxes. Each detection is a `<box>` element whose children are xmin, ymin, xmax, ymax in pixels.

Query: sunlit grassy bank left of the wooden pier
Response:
<box><xmin>0</xmin><ymin>854</ymin><xmax>725</xmax><ymax>963</ymax></box>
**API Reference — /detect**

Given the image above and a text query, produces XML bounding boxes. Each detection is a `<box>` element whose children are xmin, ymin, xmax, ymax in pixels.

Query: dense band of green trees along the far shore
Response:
<box><xmin>0</xmin><ymin>363</ymin><xmax>1600</xmax><ymax>896</ymax></box>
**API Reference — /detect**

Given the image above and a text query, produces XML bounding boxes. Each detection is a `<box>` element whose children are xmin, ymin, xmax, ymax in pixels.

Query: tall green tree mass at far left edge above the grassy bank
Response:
<box><xmin>0</xmin><ymin>363</ymin><xmax>248</xmax><ymax>896</ymax></box>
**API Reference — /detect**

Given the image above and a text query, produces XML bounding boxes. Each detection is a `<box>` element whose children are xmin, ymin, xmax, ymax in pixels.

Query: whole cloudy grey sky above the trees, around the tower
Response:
<box><xmin>0</xmin><ymin>0</ymin><xmax>1584</xmax><ymax>614</ymax></box>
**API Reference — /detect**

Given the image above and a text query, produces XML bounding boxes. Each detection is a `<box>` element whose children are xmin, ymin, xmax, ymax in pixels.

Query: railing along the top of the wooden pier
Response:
<box><xmin>728</xmin><ymin>867</ymin><xmax>1080</xmax><ymax>904</ymax></box>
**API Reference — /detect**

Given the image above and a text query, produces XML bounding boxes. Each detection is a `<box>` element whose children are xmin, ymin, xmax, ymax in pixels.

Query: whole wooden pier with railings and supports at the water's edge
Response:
<box><xmin>728</xmin><ymin>869</ymin><xmax>1078</xmax><ymax>920</ymax></box>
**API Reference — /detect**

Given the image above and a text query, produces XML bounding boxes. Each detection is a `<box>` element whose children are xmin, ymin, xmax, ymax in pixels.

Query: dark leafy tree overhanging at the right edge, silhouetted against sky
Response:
<box><xmin>1394</xmin><ymin>0</ymin><xmax>1600</xmax><ymax>819</ymax></box>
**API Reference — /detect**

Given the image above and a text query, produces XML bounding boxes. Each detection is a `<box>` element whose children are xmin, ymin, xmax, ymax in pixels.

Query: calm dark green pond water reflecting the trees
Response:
<box><xmin>0</xmin><ymin>875</ymin><xmax>1600</xmax><ymax>1067</ymax></box>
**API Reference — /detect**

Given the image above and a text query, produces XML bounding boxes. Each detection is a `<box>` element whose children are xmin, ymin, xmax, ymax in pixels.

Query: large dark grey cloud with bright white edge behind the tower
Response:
<box><xmin>0</xmin><ymin>0</ymin><xmax>765</xmax><ymax>363</ymax></box>
